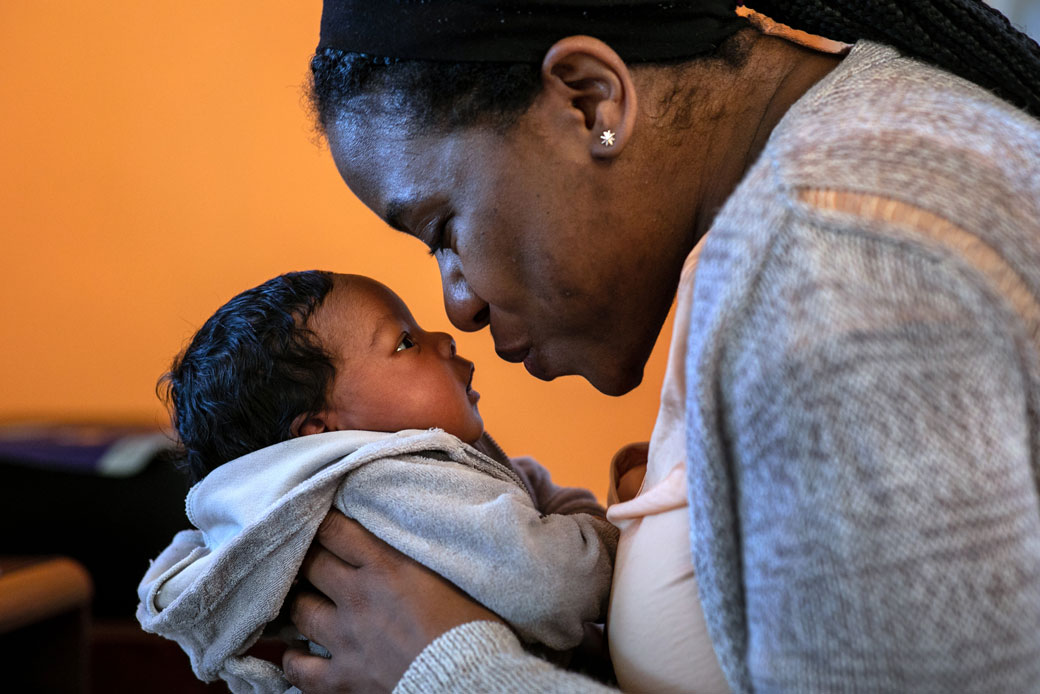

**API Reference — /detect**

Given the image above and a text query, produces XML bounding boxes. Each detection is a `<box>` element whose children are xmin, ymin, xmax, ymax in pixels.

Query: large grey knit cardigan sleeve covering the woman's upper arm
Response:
<box><xmin>716</xmin><ymin>215</ymin><xmax>1040</xmax><ymax>691</ymax></box>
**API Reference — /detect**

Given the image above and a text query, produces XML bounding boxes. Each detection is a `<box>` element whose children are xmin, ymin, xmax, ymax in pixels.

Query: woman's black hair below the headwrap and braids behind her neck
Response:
<box><xmin>311</xmin><ymin>0</ymin><xmax>1040</xmax><ymax>132</ymax></box>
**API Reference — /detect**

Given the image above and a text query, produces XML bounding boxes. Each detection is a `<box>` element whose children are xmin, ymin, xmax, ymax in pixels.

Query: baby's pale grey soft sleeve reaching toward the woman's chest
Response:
<box><xmin>336</xmin><ymin>456</ymin><xmax>618</xmax><ymax>650</ymax></box>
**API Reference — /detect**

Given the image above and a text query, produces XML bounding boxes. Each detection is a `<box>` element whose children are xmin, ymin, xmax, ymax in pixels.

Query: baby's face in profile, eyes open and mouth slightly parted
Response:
<box><xmin>301</xmin><ymin>275</ymin><xmax>484</xmax><ymax>443</ymax></box>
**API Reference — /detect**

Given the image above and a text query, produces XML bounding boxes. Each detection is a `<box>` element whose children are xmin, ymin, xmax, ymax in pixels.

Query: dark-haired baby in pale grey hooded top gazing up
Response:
<box><xmin>137</xmin><ymin>272</ymin><xmax>617</xmax><ymax>692</ymax></box>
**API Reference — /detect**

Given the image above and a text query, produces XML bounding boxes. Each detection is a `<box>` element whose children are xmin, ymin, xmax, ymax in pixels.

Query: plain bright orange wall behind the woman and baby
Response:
<box><xmin>0</xmin><ymin>0</ymin><xmax>667</xmax><ymax>496</ymax></box>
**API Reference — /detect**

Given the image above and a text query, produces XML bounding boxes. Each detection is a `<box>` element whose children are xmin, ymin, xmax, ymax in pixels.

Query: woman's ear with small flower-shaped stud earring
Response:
<box><xmin>542</xmin><ymin>36</ymin><xmax>638</xmax><ymax>159</ymax></box>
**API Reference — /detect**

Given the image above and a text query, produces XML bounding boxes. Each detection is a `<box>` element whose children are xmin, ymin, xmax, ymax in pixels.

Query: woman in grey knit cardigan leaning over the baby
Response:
<box><xmin>284</xmin><ymin>0</ymin><xmax>1040</xmax><ymax>692</ymax></box>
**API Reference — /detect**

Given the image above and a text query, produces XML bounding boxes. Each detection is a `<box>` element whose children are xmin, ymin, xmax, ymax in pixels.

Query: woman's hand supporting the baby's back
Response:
<box><xmin>282</xmin><ymin>511</ymin><xmax>501</xmax><ymax>694</ymax></box>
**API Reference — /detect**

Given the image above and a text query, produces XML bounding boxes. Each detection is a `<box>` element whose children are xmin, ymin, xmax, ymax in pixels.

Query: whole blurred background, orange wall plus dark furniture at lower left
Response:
<box><xmin>0</xmin><ymin>0</ymin><xmax>1040</xmax><ymax>694</ymax></box>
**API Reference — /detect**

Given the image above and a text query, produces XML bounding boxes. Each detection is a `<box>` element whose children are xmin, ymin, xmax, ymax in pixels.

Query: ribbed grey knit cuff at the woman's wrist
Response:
<box><xmin>394</xmin><ymin>622</ymin><xmax>617</xmax><ymax>694</ymax></box>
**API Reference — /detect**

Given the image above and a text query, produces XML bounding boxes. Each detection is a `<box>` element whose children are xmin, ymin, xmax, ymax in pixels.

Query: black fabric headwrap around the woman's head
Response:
<box><xmin>318</xmin><ymin>0</ymin><xmax>746</xmax><ymax>63</ymax></box>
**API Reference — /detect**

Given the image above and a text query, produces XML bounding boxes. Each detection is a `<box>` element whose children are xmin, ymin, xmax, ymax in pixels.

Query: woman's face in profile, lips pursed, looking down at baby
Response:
<box><xmin>329</xmin><ymin>104</ymin><xmax>681</xmax><ymax>394</ymax></box>
